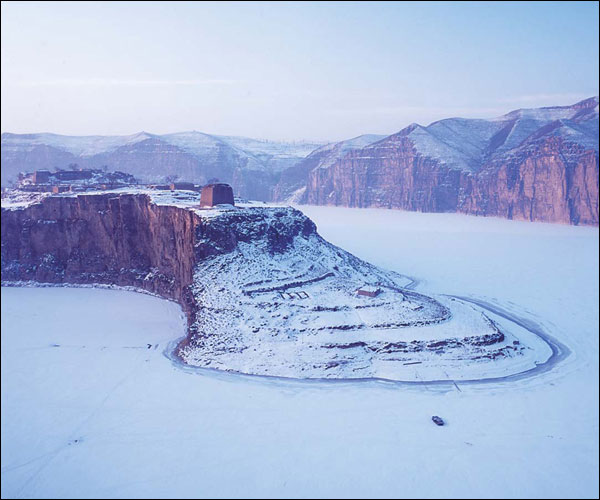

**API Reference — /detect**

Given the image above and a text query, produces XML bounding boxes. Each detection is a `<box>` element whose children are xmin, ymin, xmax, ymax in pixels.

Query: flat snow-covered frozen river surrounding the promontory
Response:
<box><xmin>1</xmin><ymin>207</ymin><xmax>598</xmax><ymax>498</ymax></box>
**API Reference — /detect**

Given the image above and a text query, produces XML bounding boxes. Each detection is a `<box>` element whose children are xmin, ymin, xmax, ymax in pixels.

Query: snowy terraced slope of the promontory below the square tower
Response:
<box><xmin>172</xmin><ymin>199</ymin><xmax>551</xmax><ymax>380</ymax></box>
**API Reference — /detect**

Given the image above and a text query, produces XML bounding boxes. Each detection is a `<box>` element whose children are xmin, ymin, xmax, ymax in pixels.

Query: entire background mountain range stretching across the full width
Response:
<box><xmin>1</xmin><ymin>97</ymin><xmax>598</xmax><ymax>225</ymax></box>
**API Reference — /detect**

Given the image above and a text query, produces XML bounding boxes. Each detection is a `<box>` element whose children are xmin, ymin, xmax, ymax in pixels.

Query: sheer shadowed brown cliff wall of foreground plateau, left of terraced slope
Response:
<box><xmin>2</xmin><ymin>194</ymin><xmax>197</xmax><ymax>318</ymax></box>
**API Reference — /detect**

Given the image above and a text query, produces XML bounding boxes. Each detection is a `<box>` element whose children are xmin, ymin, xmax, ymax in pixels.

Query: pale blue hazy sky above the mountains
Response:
<box><xmin>2</xmin><ymin>2</ymin><xmax>599</xmax><ymax>140</ymax></box>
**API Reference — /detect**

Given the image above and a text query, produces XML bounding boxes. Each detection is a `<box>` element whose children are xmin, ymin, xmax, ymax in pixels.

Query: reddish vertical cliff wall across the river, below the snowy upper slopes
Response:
<box><xmin>301</xmin><ymin>136</ymin><xmax>598</xmax><ymax>225</ymax></box>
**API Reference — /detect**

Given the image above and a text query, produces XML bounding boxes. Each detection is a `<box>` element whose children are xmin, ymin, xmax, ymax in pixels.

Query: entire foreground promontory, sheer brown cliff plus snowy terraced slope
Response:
<box><xmin>1</xmin><ymin>190</ymin><xmax>549</xmax><ymax>380</ymax></box>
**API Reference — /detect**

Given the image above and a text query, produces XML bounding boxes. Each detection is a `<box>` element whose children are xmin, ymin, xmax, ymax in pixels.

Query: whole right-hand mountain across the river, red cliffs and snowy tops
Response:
<box><xmin>301</xmin><ymin>98</ymin><xmax>598</xmax><ymax>225</ymax></box>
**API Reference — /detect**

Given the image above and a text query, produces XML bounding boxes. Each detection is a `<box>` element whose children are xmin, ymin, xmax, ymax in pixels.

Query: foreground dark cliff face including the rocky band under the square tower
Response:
<box><xmin>1</xmin><ymin>194</ymin><xmax>316</xmax><ymax>328</ymax></box>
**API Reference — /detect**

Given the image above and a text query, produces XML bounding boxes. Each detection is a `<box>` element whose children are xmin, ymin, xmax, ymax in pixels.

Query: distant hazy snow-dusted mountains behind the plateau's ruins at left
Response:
<box><xmin>2</xmin><ymin>131</ymin><xmax>322</xmax><ymax>200</ymax></box>
